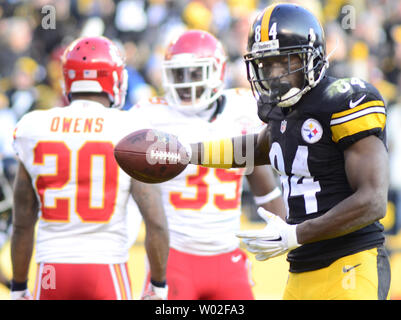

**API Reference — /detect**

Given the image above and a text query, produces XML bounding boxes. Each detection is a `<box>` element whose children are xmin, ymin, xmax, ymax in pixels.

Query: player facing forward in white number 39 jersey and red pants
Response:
<box><xmin>130</xmin><ymin>30</ymin><xmax>285</xmax><ymax>300</ymax></box>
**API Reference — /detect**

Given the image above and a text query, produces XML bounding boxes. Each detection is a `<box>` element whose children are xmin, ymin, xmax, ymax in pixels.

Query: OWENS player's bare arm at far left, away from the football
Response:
<box><xmin>11</xmin><ymin>162</ymin><xmax>38</xmax><ymax>291</ymax></box>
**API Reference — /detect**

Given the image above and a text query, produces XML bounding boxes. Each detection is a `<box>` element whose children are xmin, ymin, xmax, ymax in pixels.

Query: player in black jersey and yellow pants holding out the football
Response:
<box><xmin>185</xmin><ymin>4</ymin><xmax>390</xmax><ymax>299</ymax></box>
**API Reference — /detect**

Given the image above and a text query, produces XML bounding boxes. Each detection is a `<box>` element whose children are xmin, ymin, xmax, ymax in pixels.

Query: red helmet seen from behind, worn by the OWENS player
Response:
<box><xmin>62</xmin><ymin>37</ymin><xmax>128</xmax><ymax>107</ymax></box>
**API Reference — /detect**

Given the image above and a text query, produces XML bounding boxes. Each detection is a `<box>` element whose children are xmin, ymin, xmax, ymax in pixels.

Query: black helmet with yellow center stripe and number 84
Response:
<box><xmin>244</xmin><ymin>3</ymin><xmax>328</xmax><ymax>111</ymax></box>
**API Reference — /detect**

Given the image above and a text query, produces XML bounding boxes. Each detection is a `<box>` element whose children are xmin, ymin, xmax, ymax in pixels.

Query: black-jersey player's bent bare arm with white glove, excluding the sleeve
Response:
<box><xmin>237</xmin><ymin>135</ymin><xmax>388</xmax><ymax>261</ymax></box>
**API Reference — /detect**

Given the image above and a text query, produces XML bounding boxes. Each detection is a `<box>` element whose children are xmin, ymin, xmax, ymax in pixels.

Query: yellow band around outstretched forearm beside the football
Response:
<box><xmin>202</xmin><ymin>138</ymin><xmax>234</xmax><ymax>169</ymax></box>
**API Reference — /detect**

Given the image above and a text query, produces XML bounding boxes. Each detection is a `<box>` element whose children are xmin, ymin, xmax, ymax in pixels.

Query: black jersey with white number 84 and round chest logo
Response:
<box><xmin>268</xmin><ymin>77</ymin><xmax>386</xmax><ymax>272</ymax></box>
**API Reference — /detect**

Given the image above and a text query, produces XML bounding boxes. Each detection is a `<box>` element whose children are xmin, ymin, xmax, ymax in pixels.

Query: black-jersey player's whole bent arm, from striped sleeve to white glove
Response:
<box><xmin>237</xmin><ymin>78</ymin><xmax>389</xmax><ymax>260</ymax></box>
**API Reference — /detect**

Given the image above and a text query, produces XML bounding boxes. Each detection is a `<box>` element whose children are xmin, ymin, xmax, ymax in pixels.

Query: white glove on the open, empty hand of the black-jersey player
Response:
<box><xmin>236</xmin><ymin>208</ymin><xmax>300</xmax><ymax>261</ymax></box>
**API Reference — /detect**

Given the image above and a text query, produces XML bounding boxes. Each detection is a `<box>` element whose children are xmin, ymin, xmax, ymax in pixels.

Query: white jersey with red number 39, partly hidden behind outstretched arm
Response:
<box><xmin>130</xmin><ymin>89</ymin><xmax>263</xmax><ymax>255</ymax></box>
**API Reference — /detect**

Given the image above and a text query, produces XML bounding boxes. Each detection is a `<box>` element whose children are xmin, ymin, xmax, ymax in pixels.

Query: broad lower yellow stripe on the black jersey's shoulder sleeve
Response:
<box><xmin>331</xmin><ymin>110</ymin><xmax>386</xmax><ymax>143</ymax></box>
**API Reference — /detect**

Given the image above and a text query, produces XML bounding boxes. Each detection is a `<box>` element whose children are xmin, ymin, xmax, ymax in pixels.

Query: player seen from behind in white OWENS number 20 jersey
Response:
<box><xmin>11</xmin><ymin>37</ymin><xmax>168</xmax><ymax>300</ymax></box>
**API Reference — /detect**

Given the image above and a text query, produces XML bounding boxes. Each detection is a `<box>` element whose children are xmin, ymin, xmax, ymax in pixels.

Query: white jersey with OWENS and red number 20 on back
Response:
<box><xmin>14</xmin><ymin>100</ymin><xmax>146</xmax><ymax>264</ymax></box>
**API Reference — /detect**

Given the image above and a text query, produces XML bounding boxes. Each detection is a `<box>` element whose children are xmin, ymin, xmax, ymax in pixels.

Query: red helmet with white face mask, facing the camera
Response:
<box><xmin>163</xmin><ymin>30</ymin><xmax>226</xmax><ymax>113</ymax></box>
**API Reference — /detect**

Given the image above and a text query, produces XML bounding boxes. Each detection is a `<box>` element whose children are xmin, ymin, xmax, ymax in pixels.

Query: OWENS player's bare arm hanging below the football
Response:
<box><xmin>131</xmin><ymin>180</ymin><xmax>169</xmax><ymax>294</ymax></box>
